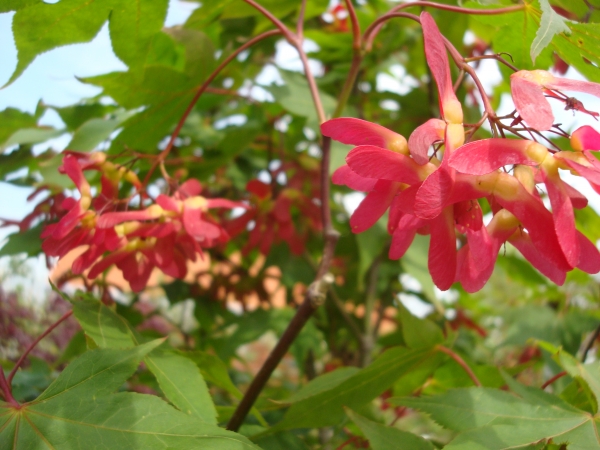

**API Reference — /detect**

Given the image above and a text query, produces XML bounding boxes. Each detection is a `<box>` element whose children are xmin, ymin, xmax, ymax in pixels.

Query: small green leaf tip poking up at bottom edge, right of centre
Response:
<box><xmin>346</xmin><ymin>409</ymin><xmax>434</xmax><ymax>450</ymax></box>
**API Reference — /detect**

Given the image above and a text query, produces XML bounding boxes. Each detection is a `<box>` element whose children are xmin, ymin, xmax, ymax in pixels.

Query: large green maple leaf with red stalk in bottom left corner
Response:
<box><xmin>0</xmin><ymin>340</ymin><xmax>257</xmax><ymax>449</ymax></box>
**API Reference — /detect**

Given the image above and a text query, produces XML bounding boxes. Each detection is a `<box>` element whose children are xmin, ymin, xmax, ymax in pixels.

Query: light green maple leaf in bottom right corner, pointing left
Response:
<box><xmin>390</xmin><ymin>386</ymin><xmax>600</xmax><ymax>450</ymax></box>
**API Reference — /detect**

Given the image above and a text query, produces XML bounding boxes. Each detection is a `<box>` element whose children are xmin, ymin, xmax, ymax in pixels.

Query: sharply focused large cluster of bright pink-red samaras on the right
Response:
<box><xmin>321</xmin><ymin>13</ymin><xmax>600</xmax><ymax>292</ymax></box>
